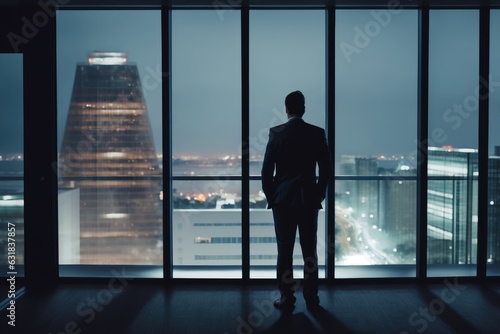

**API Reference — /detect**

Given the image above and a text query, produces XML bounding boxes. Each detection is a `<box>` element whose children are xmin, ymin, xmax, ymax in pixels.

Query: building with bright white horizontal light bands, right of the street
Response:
<box><xmin>427</xmin><ymin>147</ymin><xmax>478</xmax><ymax>264</ymax></box>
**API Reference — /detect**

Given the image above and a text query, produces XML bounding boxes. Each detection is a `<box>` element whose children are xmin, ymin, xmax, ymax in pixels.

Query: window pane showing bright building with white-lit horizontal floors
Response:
<box><xmin>427</xmin><ymin>10</ymin><xmax>479</xmax><ymax>277</ymax></box>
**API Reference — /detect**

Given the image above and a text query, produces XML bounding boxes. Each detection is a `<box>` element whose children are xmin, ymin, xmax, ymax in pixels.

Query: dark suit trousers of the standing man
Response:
<box><xmin>272</xmin><ymin>206</ymin><xmax>319</xmax><ymax>301</ymax></box>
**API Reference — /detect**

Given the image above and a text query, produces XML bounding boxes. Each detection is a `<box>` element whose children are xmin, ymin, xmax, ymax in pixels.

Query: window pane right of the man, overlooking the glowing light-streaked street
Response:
<box><xmin>335</xmin><ymin>9</ymin><xmax>418</xmax><ymax>277</ymax></box>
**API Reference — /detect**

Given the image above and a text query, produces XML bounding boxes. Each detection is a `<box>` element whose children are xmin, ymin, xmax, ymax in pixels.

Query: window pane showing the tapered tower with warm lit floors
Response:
<box><xmin>57</xmin><ymin>11</ymin><xmax>163</xmax><ymax>277</ymax></box>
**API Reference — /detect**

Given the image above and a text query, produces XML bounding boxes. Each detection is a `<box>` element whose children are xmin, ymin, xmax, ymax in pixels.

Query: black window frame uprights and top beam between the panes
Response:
<box><xmin>0</xmin><ymin>0</ymin><xmax>500</xmax><ymax>288</ymax></box>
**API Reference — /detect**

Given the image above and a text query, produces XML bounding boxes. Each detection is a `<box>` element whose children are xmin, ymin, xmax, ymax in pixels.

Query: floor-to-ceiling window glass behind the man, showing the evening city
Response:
<box><xmin>47</xmin><ymin>6</ymin><xmax>500</xmax><ymax>278</ymax></box>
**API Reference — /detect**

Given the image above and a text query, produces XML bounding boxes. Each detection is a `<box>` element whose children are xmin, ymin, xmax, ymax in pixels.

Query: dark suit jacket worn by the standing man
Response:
<box><xmin>262</xmin><ymin>118</ymin><xmax>333</xmax><ymax>209</ymax></box>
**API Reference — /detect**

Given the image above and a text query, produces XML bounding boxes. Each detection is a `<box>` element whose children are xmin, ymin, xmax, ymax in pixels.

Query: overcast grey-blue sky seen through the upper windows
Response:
<box><xmin>0</xmin><ymin>10</ymin><xmax>500</xmax><ymax>157</ymax></box>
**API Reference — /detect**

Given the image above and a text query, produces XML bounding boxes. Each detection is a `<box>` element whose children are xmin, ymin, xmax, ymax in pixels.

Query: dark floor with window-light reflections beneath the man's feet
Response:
<box><xmin>0</xmin><ymin>278</ymin><xmax>500</xmax><ymax>334</ymax></box>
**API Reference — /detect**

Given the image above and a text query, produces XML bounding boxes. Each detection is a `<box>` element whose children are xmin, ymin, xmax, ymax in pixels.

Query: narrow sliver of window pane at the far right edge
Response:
<box><xmin>487</xmin><ymin>10</ymin><xmax>500</xmax><ymax>276</ymax></box>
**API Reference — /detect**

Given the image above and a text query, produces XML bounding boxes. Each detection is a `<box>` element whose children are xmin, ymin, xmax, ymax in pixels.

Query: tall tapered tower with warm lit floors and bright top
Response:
<box><xmin>59</xmin><ymin>52</ymin><xmax>163</xmax><ymax>265</ymax></box>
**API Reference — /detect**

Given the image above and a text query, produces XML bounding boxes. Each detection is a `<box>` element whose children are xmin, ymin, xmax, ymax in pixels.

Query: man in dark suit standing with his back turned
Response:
<box><xmin>262</xmin><ymin>91</ymin><xmax>333</xmax><ymax>310</ymax></box>
